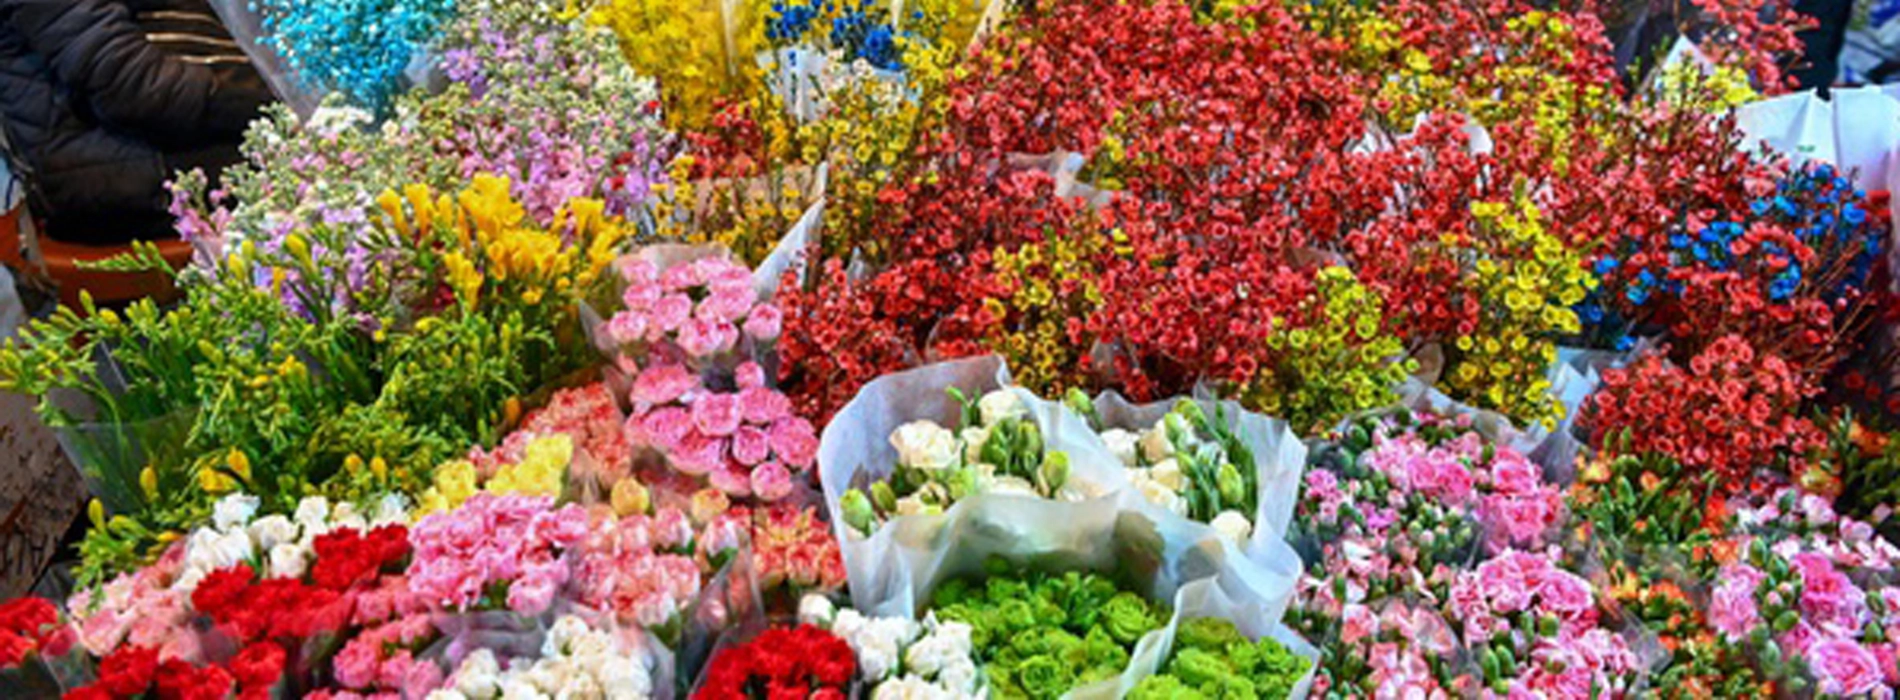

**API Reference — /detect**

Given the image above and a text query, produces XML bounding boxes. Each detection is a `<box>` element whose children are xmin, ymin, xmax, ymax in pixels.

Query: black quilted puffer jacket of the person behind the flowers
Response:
<box><xmin>0</xmin><ymin>0</ymin><xmax>270</xmax><ymax>242</ymax></box>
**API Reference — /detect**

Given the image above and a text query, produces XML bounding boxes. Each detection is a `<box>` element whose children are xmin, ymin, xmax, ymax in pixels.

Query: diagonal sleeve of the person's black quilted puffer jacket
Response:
<box><xmin>10</xmin><ymin>0</ymin><xmax>264</xmax><ymax>139</ymax></box>
